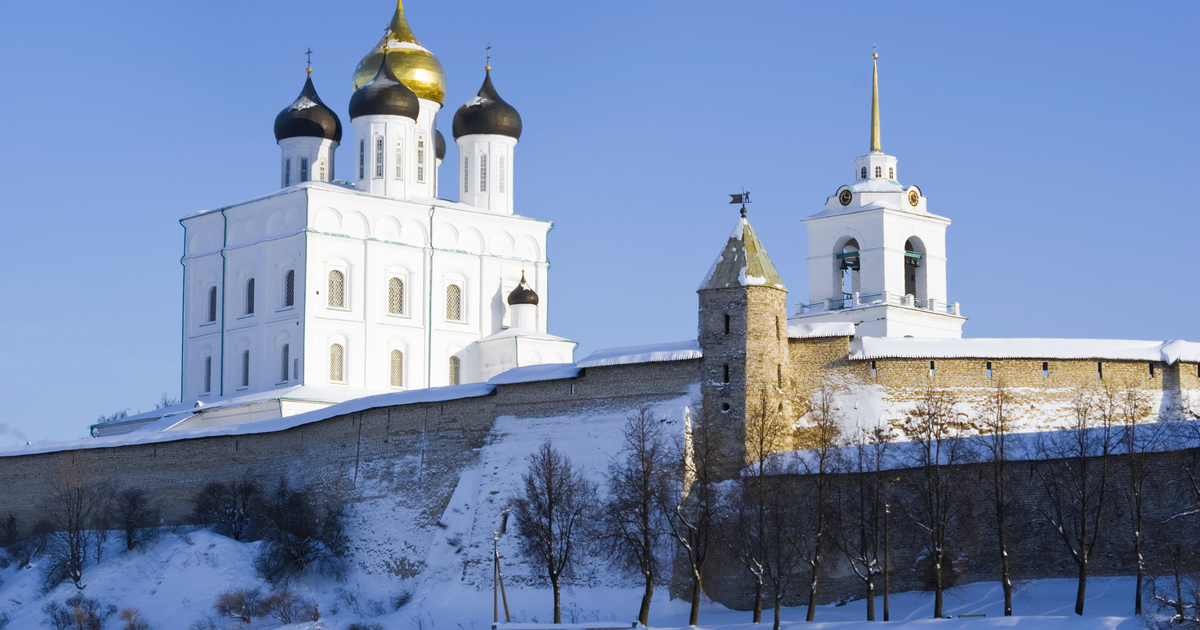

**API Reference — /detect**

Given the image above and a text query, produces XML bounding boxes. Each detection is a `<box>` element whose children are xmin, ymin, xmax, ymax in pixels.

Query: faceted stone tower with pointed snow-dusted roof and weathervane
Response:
<box><xmin>697</xmin><ymin>208</ymin><xmax>788</xmax><ymax>474</ymax></box>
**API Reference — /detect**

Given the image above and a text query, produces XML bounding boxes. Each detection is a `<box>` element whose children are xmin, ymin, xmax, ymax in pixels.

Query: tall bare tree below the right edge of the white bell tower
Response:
<box><xmin>901</xmin><ymin>383</ymin><xmax>966</xmax><ymax>618</ymax></box>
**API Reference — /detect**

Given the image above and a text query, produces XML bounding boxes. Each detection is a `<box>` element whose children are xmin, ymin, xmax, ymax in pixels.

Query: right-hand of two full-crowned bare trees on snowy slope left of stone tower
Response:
<box><xmin>599</xmin><ymin>406</ymin><xmax>668</xmax><ymax>626</ymax></box>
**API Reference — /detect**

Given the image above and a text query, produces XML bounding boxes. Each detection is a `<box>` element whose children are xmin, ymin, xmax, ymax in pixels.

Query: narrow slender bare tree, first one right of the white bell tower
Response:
<box><xmin>974</xmin><ymin>378</ymin><xmax>1019</xmax><ymax>617</ymax></box>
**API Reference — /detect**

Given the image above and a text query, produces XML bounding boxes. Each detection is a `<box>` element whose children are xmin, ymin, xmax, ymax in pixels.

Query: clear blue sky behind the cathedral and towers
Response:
<box><xmin>0</xmin><ymin>0</ymin><xmax>1200</xmax><ymax>446</ymax></box>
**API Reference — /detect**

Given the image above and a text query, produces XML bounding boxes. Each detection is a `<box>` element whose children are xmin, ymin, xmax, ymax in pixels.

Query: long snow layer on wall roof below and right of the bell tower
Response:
<box><xmin>850</xmin><ymin>337</ymin><xmax>1200</xmax><ymax>364</ymax></box>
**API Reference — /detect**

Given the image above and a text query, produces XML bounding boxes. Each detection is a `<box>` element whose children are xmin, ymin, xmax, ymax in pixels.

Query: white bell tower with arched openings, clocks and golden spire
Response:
<box><xmin>790</xmin><ymin>54</ymin><xmax>966</xmax><ymax>338</ymax></box>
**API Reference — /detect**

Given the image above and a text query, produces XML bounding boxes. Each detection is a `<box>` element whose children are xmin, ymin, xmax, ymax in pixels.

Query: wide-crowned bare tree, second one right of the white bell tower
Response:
<box><xmin>1038</xmin><ymin>386</ymin><xmax>1118</xmax><ymax>616</ymax></box>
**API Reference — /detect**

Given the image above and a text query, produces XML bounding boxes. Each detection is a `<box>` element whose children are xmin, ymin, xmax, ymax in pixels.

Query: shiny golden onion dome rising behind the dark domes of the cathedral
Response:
<box><xmin>354</xmin><ymin>0</ymin><xmax>446</xmax><ymax>103</ymax></box>
